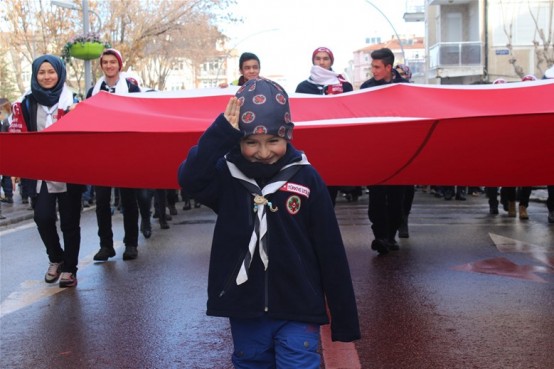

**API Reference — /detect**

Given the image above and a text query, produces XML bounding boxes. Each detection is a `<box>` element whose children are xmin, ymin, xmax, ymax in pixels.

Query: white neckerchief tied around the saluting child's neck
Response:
<box><xmin>227</xmin><ymin>154</ymin><xmax>310</xmax><ymax>285</ymax></box>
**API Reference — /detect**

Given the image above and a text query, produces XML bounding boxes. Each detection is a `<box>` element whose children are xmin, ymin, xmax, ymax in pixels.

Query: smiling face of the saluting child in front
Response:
<box><xmin>240</xmin><ymin>135</ymin><xmax>287</xmax><ymax>164</ymax></box>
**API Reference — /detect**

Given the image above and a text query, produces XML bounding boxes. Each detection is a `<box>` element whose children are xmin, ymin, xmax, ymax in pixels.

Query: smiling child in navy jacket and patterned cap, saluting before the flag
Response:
<box><xmin>178</xmin><ymin>79</ymin><xmax>360</xmax><ymax>369</ymax></box>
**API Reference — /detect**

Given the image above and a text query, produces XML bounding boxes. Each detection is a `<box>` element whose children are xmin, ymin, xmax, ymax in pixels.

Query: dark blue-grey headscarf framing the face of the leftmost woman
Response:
<box><xmin>31</xmin><ymin>54</ymin><xmax>65</xmax><ymax>106</ymax></box>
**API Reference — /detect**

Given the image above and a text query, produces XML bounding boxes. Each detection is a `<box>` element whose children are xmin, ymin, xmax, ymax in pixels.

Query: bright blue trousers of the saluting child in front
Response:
<box><xmin>229</xmin><ymin>316</ymin><xmax>321</xmax><ymax>369</ymax></box>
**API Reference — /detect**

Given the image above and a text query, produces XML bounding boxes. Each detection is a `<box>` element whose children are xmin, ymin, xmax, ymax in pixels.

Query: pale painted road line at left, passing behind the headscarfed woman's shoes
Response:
<box><xmin>0</xmin><ymin>242</ymin><xmax>123</xmax><ymax>319</ymax></box>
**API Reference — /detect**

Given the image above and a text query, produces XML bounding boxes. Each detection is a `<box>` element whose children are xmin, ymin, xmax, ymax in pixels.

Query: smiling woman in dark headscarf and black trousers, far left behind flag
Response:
<box><xmin>10</xmin><ymin>55</ymin><xmax>84</xmax><ymax>287</ymax></box>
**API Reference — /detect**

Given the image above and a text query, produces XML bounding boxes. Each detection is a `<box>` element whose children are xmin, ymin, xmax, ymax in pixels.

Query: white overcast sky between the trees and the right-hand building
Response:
<box><xmin>219</xmin><ymin>0</ymin><xmax>424</xmax><ymax>92</ymax></box>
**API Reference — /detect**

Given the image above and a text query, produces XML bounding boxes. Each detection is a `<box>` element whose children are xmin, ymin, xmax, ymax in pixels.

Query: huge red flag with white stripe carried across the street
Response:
<box><xmin>0</xmin><ymin>81</ymin><xmax>554</xmax><ymax>188</ymax></box>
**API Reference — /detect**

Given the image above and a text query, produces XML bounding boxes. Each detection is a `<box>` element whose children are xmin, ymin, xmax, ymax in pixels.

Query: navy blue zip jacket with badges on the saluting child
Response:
<box><xmin>178</xmin><ymin>114</ymin><xmax>360</xmax><ymax>342</ymax></box>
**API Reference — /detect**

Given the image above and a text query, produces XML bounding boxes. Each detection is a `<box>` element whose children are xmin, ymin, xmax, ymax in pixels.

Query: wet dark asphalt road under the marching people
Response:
<box><xmin>0</xmin><ymin>188</ymin><xmax>554</xmax><ymax>369</ymax></box>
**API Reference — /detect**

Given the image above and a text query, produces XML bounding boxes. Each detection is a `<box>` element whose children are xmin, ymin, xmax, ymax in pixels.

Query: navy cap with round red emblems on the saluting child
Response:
<box><xmin>235</xmin><ymin>78</ymin><xmax>294</xmax><ymax>140</ymax></box>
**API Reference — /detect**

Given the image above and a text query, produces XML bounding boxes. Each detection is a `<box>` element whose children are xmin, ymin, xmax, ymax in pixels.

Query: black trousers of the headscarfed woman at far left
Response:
<box><xmin>32</xmin><ymin>182</ymin><xmax>83</xmax><ymax>273</ymax></box>
